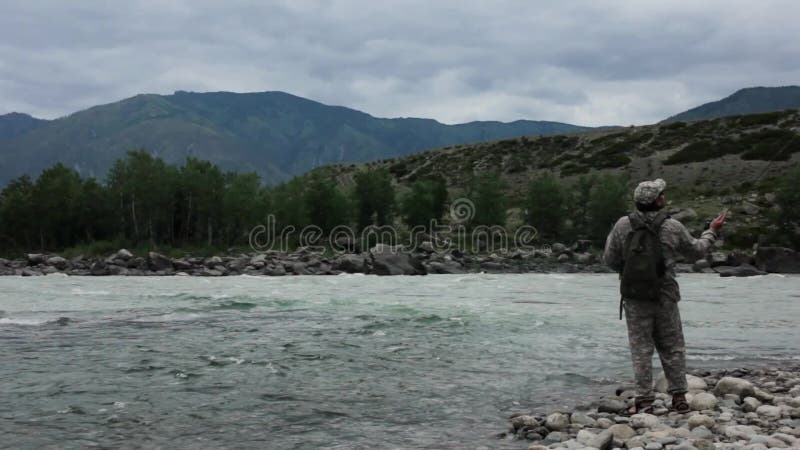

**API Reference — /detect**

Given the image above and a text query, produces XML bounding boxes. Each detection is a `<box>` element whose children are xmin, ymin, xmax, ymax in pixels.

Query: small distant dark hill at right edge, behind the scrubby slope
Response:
<box><xmin>664</xmin><ymin>86</ymin><xmax>800</xmax><ymax>122</ymax></box>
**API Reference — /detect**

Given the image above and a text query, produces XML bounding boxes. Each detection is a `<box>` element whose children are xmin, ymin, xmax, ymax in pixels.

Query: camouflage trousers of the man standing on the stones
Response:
<box><xmin>625</xmin><ymin>299</ymin><xmax>687</xmax><ymax>399</ymax></box>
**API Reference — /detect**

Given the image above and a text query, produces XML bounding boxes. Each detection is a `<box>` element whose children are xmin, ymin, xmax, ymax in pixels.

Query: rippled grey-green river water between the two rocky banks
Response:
<box><xmin>0</xmin><ymin>274</ymin><xmax>800</xmax><ymax>448</ymax></box>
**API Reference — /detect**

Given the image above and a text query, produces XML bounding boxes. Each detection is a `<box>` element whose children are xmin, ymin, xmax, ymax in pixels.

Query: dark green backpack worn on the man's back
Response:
<box><xmin>619</xmin><ymin>212</ymin><xmax>669</xmax><ymax>301</ymax></box>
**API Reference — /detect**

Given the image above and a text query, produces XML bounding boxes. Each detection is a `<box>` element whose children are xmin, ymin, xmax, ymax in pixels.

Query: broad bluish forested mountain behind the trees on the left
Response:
<box><xmin>0</xmin><ymin>91</ymin><xmax>586</xmax><ymax>185</ymax></box>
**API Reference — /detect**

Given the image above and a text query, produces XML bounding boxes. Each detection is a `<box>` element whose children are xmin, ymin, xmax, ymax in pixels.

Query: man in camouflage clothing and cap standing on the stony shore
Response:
<box><xmin>603</xmin><ymin>179</ymin><xmax>725</xmax><ymax>413</ymax></box>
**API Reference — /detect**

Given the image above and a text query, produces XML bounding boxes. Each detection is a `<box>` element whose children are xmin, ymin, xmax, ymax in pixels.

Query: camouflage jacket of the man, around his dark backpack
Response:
<box><xmin>603</xmin><ymin>211</ymin><xmax>717</xmax><ymax>302</ymax></box>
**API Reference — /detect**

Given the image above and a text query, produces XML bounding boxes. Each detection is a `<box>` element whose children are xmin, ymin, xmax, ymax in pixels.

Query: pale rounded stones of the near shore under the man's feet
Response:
<box><xmin>499</xmin><ymin>366</ymin><xmax>800</xmax><ymax>450</ymax></box>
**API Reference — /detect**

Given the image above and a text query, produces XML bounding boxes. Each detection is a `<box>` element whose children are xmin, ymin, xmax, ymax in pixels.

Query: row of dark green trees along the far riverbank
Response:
<box><xmin>6</xmin><ymin>150</ymin><xmax>800</xmax><ymax>254</ymax></box>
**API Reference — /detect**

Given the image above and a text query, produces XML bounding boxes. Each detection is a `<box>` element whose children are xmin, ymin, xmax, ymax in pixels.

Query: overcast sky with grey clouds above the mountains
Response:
<box><xmin>0</xmin><ymin>0</ymin><xmax>800</xmax><ymax>125</ymax></box>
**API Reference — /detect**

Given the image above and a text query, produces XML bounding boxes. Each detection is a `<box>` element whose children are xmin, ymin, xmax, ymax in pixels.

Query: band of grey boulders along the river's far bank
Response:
<box><xmin>0</xmin><ymin>241</ymin><xmax>800</xmax><ymax>276</ymax></box>
